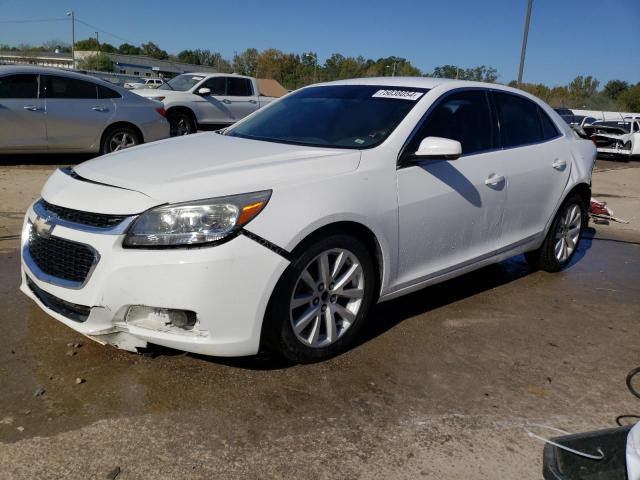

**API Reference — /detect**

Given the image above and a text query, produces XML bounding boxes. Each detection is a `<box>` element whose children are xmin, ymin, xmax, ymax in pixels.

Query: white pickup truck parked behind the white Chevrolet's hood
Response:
<box><xmin>135</xmin><ymin>73</ymin><xmax>274</xmax><ymax>136</ymax></box>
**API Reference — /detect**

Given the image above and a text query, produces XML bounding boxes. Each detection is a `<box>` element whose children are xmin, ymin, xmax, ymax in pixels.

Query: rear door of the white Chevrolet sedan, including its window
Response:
<box><xmin>492</xmin><ymin>91</ymin><xmax>572</xmax><ymax>246</ymax></box>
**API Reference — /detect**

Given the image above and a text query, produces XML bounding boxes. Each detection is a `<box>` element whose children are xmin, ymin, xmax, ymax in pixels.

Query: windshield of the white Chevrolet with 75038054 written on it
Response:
<box><xmin>225</xmin><ymin>85</ymin><xmax>428</xmax><ymax>149</ymax></box>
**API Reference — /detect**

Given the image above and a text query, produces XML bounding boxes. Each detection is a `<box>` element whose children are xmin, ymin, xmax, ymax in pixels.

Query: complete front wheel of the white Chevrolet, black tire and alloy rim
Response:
<box><xmin>262</xmin><ymin>233</ymin><xmax>377</xmax><ymax>363</ymax></box>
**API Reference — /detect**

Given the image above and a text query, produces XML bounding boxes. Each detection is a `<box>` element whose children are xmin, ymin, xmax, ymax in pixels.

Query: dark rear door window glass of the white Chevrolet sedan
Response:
<box><xmin>494</xmin><ymin>92</ymin><xmax>544</xmax><ymax>147</ymax></box>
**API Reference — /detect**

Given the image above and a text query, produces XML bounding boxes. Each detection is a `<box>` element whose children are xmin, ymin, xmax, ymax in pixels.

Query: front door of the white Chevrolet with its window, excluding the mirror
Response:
<box><xmin>397</xmin><ymin>90</ymin><xmax>507</xmax><ymax>288</ymax></box>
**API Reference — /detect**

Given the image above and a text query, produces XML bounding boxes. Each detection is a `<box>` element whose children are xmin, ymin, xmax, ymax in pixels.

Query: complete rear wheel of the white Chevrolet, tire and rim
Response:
<box><xmin>525</xmin><ymin>194</ymin><xmax>588</xmax><ymax>272</ymax></box>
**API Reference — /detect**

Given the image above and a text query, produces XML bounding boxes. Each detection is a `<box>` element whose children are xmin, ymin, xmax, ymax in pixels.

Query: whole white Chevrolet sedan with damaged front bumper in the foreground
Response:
<box><xmin>21</xmin><ymin>77</ymin><xmax>596</xmax><ymax>362</ymax></box>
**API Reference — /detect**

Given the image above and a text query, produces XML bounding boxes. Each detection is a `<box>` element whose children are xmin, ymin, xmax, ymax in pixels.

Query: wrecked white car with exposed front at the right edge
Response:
<box><xmin>583</xmin><ymin>117</ymin><xmax>640</xmax><ymax>162</ymax></box>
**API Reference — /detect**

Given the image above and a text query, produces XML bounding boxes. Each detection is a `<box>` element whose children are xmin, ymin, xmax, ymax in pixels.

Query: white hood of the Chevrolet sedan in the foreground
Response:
<box><xmin>74</xmin><ymin>132</ymin><xmax>360</xmax><ymax>203</ymax></box>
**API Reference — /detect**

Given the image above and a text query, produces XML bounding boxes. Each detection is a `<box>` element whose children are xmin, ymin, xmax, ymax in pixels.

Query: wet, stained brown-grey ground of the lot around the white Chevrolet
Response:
<box><xmin>0</xmin><ymin>158</ymin><xmax>640</xmax><ymax>479</ymax></box>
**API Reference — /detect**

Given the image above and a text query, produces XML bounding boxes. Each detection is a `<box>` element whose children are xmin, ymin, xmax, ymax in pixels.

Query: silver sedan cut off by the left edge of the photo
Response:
<box><xmin>0</xmin><ymin>66</ymin><xmax>169</xmax><ymax>153</ymax></box>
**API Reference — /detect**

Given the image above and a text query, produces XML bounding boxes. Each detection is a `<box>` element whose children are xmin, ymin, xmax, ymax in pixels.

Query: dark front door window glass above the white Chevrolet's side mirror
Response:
<box><xmin>409</xmin><ymin>90</ymin><xmax>497</xmax><ymax>155</ymax></box>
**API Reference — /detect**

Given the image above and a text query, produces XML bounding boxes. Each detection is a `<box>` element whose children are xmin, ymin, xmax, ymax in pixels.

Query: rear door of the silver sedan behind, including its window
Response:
<box><xmin>42</xmin><ymin>75</ymin><xmax>114</xmax><ymax>151</ymax></box>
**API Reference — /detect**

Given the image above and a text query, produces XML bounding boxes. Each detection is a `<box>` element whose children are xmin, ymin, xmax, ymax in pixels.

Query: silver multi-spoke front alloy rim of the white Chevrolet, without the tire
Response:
<box><xmin>289</xmin><ymin>248</ymin><xmax>365</xmax><ymax>348</ymax></box>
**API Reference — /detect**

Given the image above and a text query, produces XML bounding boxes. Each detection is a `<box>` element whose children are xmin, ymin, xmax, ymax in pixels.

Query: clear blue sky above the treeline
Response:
<box><xmin>0</xmin><ymin>0</ymin><xmax>640</xmax><ymax>86</ymax></box>
